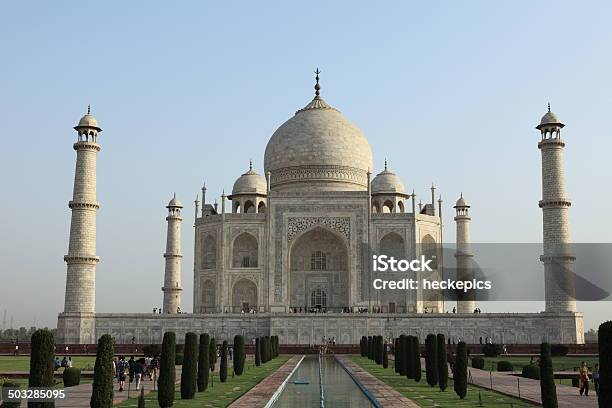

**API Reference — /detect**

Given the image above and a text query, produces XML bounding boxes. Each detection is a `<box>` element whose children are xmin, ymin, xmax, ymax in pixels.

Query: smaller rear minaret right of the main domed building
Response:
<box><xmin>454</xmin><ymin>193</ymin><xmax>476</xmax><ymax>313</ymax></box>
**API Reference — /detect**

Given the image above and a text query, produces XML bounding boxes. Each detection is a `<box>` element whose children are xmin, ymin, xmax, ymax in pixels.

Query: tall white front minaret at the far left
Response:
<box><xmin>64</xmin><ymin>106</ymin><xmax>102</xmax><ymax>314</ymax></box>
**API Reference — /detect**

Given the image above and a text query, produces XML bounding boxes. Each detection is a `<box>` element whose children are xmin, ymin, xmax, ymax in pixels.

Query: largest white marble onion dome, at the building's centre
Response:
<box><xmin>264</xmin><ymin>95</ymin><xmax>372</xmax><ymax>191</ymax></box>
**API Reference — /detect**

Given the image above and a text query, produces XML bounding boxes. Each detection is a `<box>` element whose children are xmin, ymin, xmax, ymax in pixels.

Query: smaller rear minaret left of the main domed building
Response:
<box><xmin>162</xmin><ymin>194</ymin><xmax>183</xmax><ymax>314</ymax></box>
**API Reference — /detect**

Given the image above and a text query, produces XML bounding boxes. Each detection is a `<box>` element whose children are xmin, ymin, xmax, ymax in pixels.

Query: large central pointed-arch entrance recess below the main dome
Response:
<box><xmin>289</xmin><ymin>227</ymin><xmax>350</xmax><ymax>312</ymax></box>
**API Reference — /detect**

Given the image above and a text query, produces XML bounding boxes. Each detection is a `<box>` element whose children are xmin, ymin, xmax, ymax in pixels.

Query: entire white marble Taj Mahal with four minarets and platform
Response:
<box><xmin>58</xmin><ymin>70</ymin><xmax>584</xmax><ymax>345</ymax></box>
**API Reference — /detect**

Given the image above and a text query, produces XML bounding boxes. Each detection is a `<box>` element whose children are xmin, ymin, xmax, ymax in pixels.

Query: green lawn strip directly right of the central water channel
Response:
<box><xmin>350</xmin><ymin>355</ymin><xmax>533</xmax><ymax>408</ymax></box>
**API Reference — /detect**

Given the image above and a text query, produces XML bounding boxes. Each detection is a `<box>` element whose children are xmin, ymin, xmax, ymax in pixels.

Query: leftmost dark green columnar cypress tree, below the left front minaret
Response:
<box><xmin>28</xmin><ymin>329</ymin><xmax>55</xmax><ymax>408</ymax></box>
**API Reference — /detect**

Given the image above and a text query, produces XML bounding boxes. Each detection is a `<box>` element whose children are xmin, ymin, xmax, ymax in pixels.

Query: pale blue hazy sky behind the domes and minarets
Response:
<box><xmin>0</xmin><ymin>1</ymin><xmax>612</xmax><ymax>328</ymax></box>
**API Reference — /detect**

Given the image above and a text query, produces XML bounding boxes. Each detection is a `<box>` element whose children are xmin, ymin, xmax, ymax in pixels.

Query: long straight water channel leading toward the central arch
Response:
<box><xmin>273</xmin><ymin>355</ymin><xmax>374</xmax><ymax>408</ymax></box>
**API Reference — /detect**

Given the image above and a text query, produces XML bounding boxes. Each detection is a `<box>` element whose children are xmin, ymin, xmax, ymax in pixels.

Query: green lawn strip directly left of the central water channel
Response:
<box><xmin>118</xmin><ymin>355</ymin><xmax>291</xmax><ymax>408</ymax></box>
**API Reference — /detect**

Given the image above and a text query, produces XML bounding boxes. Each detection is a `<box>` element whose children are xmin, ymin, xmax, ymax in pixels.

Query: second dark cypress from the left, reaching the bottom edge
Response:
<box><xmin>89</xmin><ymin>334</ymin><xmax>113</xmax><ymax>408</ymax></box>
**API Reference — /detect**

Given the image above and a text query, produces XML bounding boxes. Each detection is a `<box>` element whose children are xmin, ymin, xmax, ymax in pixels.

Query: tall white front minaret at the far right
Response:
<box><xmin>536</xmin><ymin>104</ymin><xmax>576</xmax><ymax>312</ymax></box>
